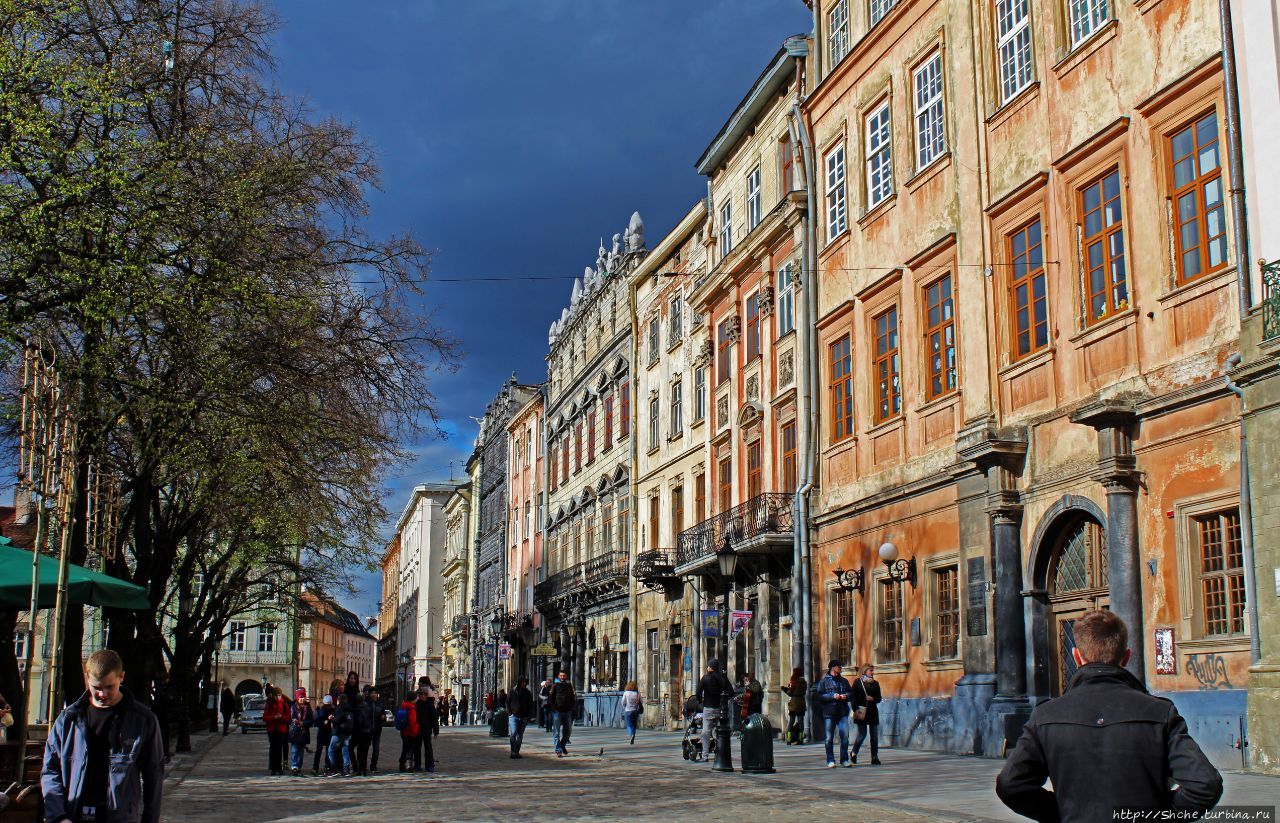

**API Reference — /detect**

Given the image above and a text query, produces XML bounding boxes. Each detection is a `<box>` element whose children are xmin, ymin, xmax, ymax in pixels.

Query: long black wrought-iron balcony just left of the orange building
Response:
<box><xmin>675</xmin><ymin>493</ymin><xmax>795</xmax><ymax>575</ymax></box>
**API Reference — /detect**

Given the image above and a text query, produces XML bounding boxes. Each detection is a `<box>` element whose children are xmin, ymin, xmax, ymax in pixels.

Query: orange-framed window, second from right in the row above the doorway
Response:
<box><xmin>1079</xmin><ymin>169</ymin><xmax>1129</xmax><ymax>325</ymax></box>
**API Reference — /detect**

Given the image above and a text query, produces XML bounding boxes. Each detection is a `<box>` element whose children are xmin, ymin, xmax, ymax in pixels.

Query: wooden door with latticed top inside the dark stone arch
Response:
<box><xmin>1046</xmin><ymin>512</ymin><xmax>1110</xmax><ymax>696</ymax></box>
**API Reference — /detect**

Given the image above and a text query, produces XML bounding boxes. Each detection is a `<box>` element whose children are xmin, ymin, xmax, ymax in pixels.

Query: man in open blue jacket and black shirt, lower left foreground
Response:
<box><xmin>40</xmin><ymin>649</ymin><xmax>164</xmax><ymax>823</ymax></box>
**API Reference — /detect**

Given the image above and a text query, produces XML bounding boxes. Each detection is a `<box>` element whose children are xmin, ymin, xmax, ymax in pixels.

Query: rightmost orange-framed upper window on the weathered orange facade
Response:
<box><xmin>1169</xmin><ymin>111</ymin><xmax>1226</xmax><ymax>283</ymax></box>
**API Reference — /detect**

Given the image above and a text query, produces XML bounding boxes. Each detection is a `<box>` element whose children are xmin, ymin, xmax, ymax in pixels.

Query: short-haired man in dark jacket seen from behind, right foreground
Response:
<box><xmin>996</xmin><ymin>611</ymin><xmax>1222</xmax><ymax>822</ymax></box>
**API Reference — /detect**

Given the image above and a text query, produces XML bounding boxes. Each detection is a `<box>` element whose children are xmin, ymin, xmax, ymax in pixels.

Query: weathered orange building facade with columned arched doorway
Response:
<box><xmin>803</xmin><ymin>0</ymin><xmax>1249</xmax><ymax>768</ymax></box>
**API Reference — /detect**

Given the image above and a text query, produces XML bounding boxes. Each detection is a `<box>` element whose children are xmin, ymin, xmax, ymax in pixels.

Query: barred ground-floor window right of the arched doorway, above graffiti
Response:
<box><xmin>1193</xmin><ymin>508</ymin><xmax>1244</xmax><ymax>637</ymax></box>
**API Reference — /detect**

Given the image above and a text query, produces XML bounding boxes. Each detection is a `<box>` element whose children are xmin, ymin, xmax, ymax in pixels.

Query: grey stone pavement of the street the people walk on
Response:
<box><xmin>164</xmin><ymin>727</ymin><xmax>1280</xmax><ymax>823</ymax></box>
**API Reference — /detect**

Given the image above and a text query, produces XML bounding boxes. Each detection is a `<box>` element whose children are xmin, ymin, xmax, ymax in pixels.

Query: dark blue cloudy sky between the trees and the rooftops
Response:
<box><xmin>266</xmin><ymin>0</ymin><xmax>810</xmax><ymax>614</ymax></box>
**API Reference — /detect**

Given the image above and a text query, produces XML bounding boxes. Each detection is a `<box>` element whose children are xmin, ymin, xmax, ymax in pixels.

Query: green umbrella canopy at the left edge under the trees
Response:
<box><xmin>0</xmin><ymin>538</ymin><xmax>150</xmax><ymax>609</ymax></box>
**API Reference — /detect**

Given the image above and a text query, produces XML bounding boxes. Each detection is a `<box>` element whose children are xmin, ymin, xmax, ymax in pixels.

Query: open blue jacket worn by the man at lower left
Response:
<box><xmin>40</xmin><ymin>691</ymin><xmax>164</xmax><ymax>823</ymax></box>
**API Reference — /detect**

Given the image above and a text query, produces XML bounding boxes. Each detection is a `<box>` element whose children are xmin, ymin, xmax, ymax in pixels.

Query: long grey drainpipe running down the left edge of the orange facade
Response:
<box><xmin>791</xmin><ymin>102</ymin><xmax>818</xmax><ymax>682</ymax></box>
